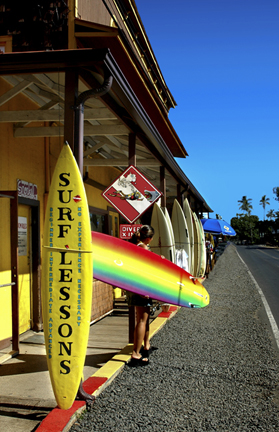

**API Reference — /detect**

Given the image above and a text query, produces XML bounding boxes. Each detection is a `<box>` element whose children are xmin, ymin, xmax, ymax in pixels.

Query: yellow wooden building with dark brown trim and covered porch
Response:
<box><xmin>0</xmin><ymin>0</ymin><xmax>212</xmax><ymax>347</ymax></box>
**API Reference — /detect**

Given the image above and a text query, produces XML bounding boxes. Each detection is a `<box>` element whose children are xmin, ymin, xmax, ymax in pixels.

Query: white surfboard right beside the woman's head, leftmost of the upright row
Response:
<box><xmin>150</xmin><ymin>203</ymin><xmax>175</xmax><ymax>262</ymax></box>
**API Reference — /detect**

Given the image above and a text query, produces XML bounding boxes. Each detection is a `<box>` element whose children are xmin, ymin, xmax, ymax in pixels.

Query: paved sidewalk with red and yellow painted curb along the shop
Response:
<box><xmin>0</xmin><ymin>308</ymin><xmax>176</xmax><ymax>432</ymax></box>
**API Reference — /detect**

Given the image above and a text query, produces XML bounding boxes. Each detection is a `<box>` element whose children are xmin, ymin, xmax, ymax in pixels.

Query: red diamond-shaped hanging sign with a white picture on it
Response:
<box><xmin>102</xmin><ymin>165</ymin><xmax>162</xmax><ymax>223</ymax></box>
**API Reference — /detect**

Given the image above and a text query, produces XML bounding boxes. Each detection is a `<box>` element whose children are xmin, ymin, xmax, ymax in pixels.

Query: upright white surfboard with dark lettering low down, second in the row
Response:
<box><xmin>171</xmin><ymin>200</ymin><xmax>191</xmax><ymax>272</ymax></box>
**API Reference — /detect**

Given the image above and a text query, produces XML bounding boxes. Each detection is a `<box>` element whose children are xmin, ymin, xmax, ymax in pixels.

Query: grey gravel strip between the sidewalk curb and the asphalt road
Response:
<box><xmin>71</xmin><ymin>244</ymin><xmax>279</xmax><ymax>432</ymax></box>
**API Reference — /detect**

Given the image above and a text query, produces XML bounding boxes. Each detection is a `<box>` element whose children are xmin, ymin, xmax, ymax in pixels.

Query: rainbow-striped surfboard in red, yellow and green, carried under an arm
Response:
<box><xmin>91</xmin><ymin>231</ymin><xmax>209</xmax><ymax>308</ymax></box>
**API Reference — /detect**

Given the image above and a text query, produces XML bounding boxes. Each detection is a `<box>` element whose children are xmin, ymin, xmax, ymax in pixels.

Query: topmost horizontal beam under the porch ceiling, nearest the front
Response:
<box><xmin>0</xmin><ymin>109</ymin><xmax>117</xmax><ymax>123</ymax></box>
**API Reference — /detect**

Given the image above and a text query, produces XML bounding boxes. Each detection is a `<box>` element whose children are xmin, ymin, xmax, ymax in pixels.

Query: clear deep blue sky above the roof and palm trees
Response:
<box><xmin>136</xmin><ymin>0</ymin><xmax>279</xmax><ymax>222</ymax></box>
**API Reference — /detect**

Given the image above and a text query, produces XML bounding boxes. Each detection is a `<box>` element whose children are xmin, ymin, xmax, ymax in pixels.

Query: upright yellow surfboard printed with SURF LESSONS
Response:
<box><xmin>42</xmin><ymin>144</ymin><xmax>93</xmax><ymax>409</ymax></box>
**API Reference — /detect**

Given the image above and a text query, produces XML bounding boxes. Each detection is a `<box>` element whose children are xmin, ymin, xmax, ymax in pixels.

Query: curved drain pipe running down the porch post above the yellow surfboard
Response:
<box><xmin>74</xmin><ymin>74</ymin><xmax>113</xmax><ymax>176</ymax></box>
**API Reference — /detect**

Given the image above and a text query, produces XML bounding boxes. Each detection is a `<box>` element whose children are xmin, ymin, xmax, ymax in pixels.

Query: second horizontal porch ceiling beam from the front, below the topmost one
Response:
<box><xmin>14</xmin><ymin>123</ymin><xmax>128</xmax><ymax>139</ymax></box>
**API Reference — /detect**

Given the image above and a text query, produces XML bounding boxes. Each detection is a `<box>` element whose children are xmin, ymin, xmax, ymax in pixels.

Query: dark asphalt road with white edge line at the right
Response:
<box><xmin>237</xmin><ymin>246</ymin><xmax>279</xmax><ymax>327</ymax></box>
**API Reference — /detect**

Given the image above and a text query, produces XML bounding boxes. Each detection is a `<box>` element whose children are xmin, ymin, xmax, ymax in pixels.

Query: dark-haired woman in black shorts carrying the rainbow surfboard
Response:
<box><xmin>126</xmin><ymin>225</ymin><xmax>154</xmax><ymax>367</ymax></box>
